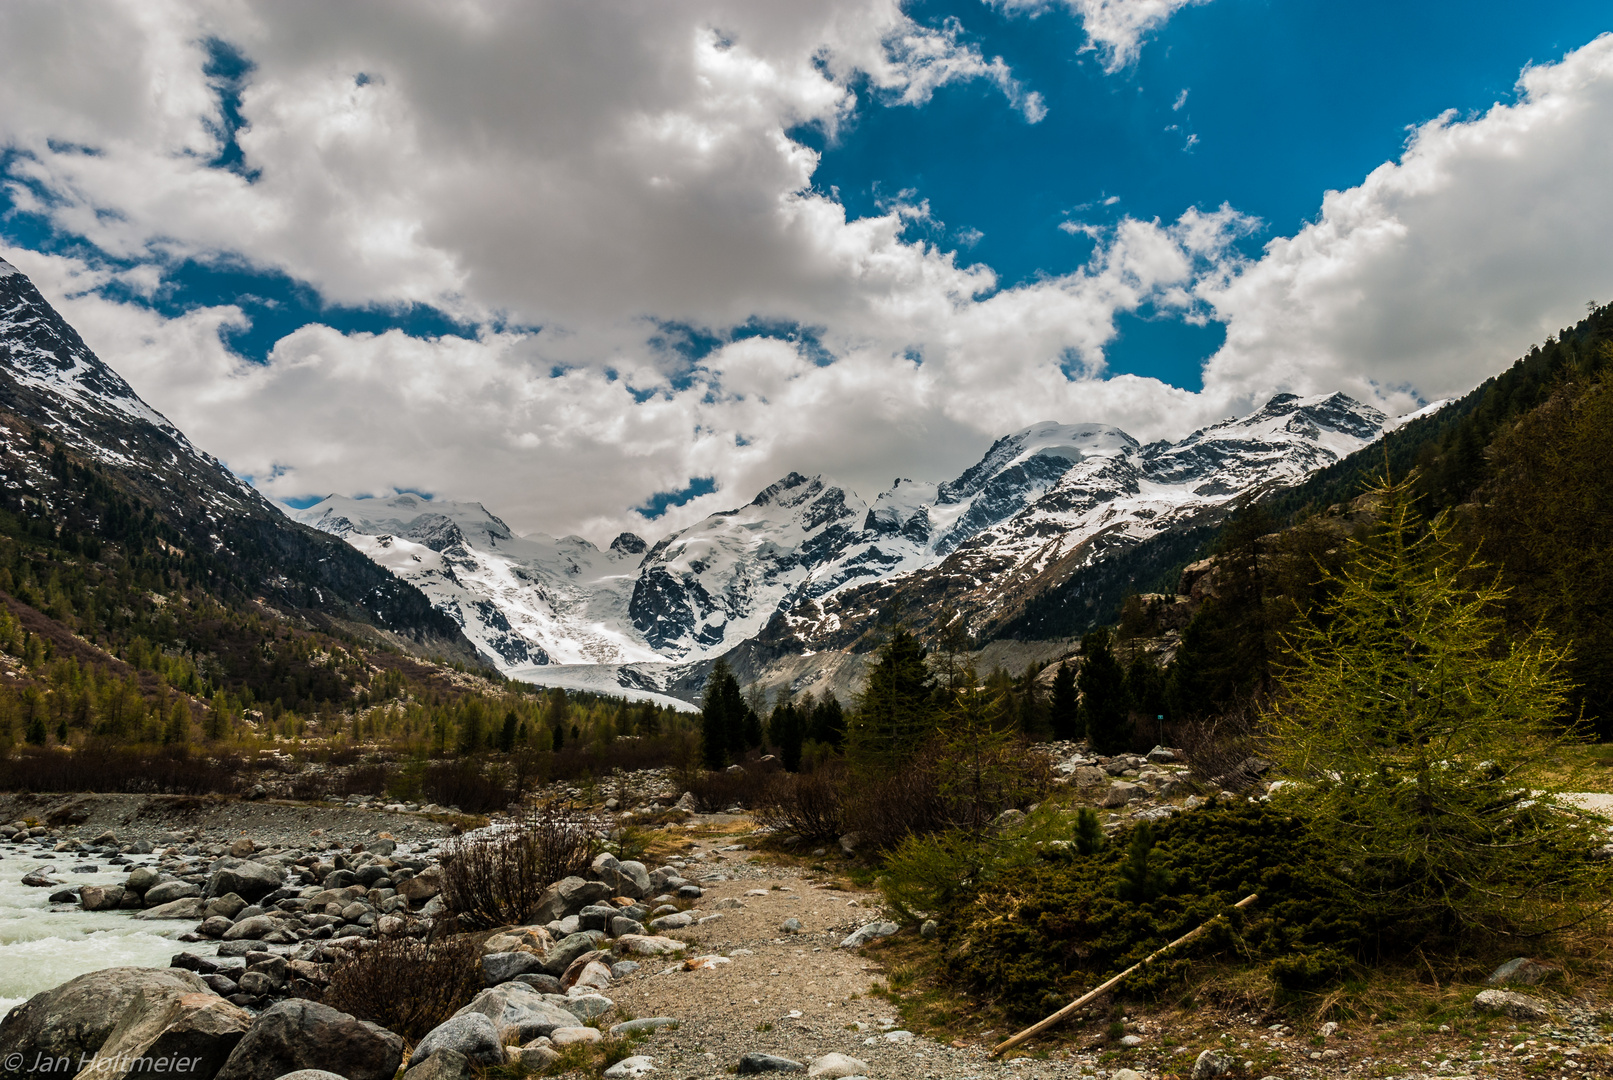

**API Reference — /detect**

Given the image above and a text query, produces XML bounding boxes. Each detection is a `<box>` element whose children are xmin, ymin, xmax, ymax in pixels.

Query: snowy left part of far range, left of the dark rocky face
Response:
<box><xmin>294</xmin><ymin>495</ymin><xmax>663</xmax><ymax>671</ymax></box>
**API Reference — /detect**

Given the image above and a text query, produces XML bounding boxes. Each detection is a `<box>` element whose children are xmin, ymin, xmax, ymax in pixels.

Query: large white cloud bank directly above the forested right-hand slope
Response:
<box><xmin>1197</xmin><ymin>34</ymin><xmax>1613</xmax><ymax>419</ymax></box>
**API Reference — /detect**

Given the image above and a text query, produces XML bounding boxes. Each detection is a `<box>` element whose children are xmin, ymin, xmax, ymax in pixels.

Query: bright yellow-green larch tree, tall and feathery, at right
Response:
<box><xmin>1266</xmin><ymin>479</ymin><xmax>1613</xmax><ymax>930</ymax></box>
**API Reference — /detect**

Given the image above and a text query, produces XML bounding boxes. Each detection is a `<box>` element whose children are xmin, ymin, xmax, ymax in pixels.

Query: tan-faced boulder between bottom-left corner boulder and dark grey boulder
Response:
<box><xmin>79</xmin><ymin>990</ymin><xmax>252</xmax><ymax>1080</ymax></box>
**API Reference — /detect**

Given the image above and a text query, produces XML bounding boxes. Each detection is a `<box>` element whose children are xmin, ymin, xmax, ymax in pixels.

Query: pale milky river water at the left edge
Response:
<box><xmin>0</xmin><ymin>843</ymin><xmax>218</xmax><ymax>1017</ymax></box>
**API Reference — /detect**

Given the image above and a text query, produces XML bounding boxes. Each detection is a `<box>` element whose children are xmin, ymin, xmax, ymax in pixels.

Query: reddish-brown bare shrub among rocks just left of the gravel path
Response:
<box><xmin>442</xmin><ymin>803</ymin><xmax>602</xmax><ymax>927</ymax></box>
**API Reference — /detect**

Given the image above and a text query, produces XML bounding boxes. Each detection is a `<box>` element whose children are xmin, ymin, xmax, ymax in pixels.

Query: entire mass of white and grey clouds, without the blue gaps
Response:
<box><xmin>0</xmin><ymin>0</ymin><xmax>1613</xmax><ymax>551</ymax></box>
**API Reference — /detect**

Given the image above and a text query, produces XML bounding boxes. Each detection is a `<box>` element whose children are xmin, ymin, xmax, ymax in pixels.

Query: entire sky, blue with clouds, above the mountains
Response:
<box><xmin>0</xmin><ymin>0</ymin><xmax>1613</xmax><ymax>534</ymax></box>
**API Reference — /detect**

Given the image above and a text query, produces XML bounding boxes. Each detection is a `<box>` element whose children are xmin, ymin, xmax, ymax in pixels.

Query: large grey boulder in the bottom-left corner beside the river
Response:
<box><xmin>0</xmin><ymin>967</ymin><xmax>210</xmax><ymax>1080</ymax></box>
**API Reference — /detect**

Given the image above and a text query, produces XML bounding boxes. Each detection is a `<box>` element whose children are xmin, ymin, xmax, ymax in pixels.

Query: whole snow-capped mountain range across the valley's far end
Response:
<box><xmin>295</xmin><ymin>395</ymin><xmax>1384</xmax><ymax>671</ymax></box>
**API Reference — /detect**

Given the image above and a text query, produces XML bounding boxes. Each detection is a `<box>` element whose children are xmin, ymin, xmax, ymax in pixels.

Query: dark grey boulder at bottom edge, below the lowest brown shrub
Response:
<box><xmin>215</xmin><ymin>998</ymin><xmax>403</xmax><ymax>1080</ymax></box>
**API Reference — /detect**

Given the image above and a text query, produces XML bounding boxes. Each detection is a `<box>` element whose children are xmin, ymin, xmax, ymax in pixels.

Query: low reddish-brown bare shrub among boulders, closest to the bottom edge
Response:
<box><xmin>323</xmin><ymin>935</ymin><xmax>482</xmax><ymax>1043</ymax></box>
